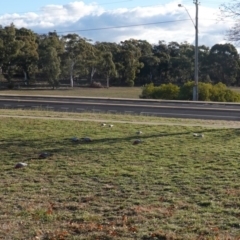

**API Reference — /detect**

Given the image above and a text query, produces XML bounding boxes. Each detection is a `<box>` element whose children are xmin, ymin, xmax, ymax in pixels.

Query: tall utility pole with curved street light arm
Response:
<box><xmin>178</xmin><ymin>0</ymin><xmax>199</xmax><ymax>101</ymax></box>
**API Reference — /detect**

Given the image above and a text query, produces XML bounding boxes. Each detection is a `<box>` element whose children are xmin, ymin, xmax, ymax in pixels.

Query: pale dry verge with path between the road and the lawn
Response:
<box><xmin>0</xmin><ymin>109</ymin><xmax>240</xmax><ymax>128</ymax></box>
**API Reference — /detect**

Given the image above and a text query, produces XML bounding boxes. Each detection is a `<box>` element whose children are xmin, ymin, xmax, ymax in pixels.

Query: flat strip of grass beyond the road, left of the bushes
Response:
<box><xmin>0</xmin><ymin>87</ymin><xmax>142</xmax><ymax>98</ymax></box>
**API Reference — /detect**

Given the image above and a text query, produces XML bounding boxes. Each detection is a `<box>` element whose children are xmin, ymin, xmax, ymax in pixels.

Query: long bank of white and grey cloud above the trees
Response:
<box><xmin>0</xmin><ymin>1</ymin><xmax>232</xmax><ymax>46</ymax></box>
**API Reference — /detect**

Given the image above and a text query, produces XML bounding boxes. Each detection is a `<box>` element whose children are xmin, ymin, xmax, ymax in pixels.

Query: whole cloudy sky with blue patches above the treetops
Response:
<box><xmin>0</xmin><ymin>0</ymin><xmax>234</xmax><ymax>47</ymax></box>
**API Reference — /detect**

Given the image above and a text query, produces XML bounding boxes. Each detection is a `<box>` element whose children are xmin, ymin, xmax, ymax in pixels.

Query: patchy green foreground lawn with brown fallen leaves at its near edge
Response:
<box><xmin>0</xmin><ymin>110</ymin><xmax>240</xmax><ymax>240</ymax></box>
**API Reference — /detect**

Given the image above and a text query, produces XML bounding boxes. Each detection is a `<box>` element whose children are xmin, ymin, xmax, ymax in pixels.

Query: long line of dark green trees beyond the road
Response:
<box><xmin>0</xmin><ymin>24</ymin><xmax>240</xmax><ymax>88</ymax></box>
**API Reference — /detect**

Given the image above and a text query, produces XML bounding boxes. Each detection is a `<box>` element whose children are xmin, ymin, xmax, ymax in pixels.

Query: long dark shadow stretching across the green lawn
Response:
<box><xmin>0</xmin><ymin>129</ymin><xmax>226</xmax><ymax>159</ymax></box>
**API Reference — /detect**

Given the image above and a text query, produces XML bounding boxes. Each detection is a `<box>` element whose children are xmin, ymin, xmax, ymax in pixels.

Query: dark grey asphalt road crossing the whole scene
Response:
<box><xmin>0</xmin><ymin>95</ymin><xmax>240</xmax><ymax>121</ymax></box>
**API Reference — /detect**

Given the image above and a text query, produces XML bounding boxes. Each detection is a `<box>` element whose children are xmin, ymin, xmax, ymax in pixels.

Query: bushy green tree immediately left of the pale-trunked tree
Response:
<box><xmin>41</xmin><ymin>46</ymin><xmax>61</xmax><ymax>89</ymax></box>
